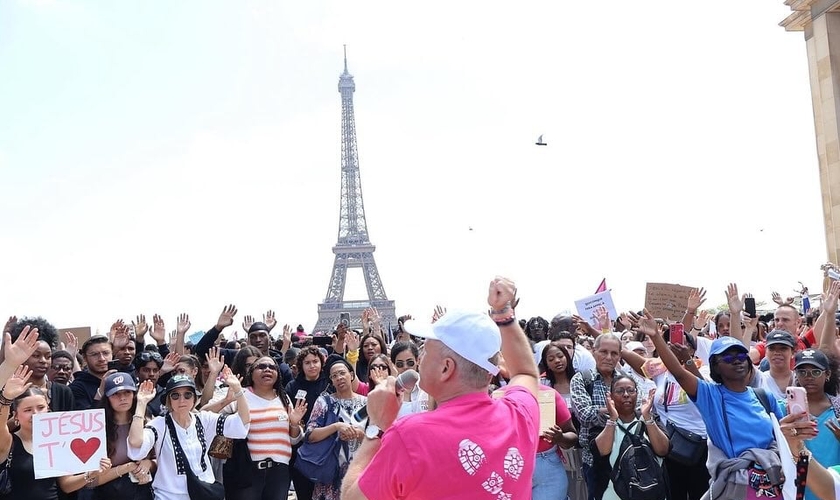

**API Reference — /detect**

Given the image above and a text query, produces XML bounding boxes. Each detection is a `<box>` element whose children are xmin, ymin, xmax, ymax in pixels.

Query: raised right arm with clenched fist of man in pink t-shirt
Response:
<box><xmin>487</xmin><ymin>277</ymin><xmax>540</xmax><ymax>397</ymax></box>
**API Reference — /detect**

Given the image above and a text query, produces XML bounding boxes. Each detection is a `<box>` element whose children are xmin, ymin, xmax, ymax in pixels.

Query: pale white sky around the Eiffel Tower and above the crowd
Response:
<box><xmin>0</xmin><ymin>0</ymin><xmax>826</xmax><ymax>336</ymax></box>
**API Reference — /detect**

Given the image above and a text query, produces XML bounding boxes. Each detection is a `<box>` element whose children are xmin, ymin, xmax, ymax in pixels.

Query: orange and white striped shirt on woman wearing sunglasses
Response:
<box><xmin>238</xmin><ymin>387</ymin><xmax>303</xmax><ymax>464</ymax></box>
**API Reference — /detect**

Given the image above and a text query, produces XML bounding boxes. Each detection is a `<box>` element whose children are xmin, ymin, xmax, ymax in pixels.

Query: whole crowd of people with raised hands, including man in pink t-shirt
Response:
<box><xmin>0</xmin><ymin>278</ymin><xmax>840</xmax><ymax>500</ymax></box>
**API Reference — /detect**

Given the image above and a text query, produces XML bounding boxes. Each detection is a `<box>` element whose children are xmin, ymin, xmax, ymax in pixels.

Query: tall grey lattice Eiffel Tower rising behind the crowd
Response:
<box><xmin>312</xmin><ymin>46</ymin><xmax>397</xmax><ymax>335</ymax></box>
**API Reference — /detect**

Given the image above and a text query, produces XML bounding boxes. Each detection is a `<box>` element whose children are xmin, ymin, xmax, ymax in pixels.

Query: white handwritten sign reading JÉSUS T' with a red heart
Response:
<box><xmin>32</xmin><ymin>408</ymin><xmax>107</xmax><ymax>479</ymax></box>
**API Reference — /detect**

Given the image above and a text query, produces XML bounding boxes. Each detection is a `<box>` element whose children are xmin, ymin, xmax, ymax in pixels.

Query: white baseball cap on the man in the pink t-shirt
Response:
<box><xmin>403</xmin><ymin>310</ymin><xmax>502</xmax><ymax>375</ymax></box>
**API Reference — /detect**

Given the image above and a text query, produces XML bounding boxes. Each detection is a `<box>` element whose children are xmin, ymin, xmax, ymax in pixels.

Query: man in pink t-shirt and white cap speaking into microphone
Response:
<box><xmin>341</xmin><ymin>278</ymin><xmax>539</xmax><ymax>500</ymax></box>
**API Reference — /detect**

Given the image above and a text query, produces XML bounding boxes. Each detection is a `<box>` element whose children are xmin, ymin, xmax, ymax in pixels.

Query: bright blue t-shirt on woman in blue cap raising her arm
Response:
<box><xmin>692</xmin><ymin>380</ymin><xmax>785</xmax><ymax>458</ymax></box>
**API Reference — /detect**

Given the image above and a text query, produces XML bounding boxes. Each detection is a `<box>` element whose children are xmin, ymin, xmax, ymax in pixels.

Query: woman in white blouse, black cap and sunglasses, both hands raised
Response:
<box><xmin>128</xmin><ymin>366</ymin><xmax>251</xmax><ymax>500</ymax></box>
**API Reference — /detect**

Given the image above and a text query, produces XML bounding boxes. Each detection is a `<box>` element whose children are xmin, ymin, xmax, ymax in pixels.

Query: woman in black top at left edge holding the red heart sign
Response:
<box><xmin>0</xmin><ymin>365</ymin><xmax>111</xmax><ymax>500</ymax></box>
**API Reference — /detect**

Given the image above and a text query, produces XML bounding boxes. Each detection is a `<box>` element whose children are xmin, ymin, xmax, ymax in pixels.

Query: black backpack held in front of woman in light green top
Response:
<box><xmin>610</xmin><ymin>420</ymin><xmax>670</xmax><ymax>500</ymax></box>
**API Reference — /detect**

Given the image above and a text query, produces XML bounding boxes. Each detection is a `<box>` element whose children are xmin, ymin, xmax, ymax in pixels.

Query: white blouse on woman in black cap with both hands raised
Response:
<box><xmin>128</xmin><ymin>411</ymin><xmax>248</xmax><ymax>500</ymax></box>
